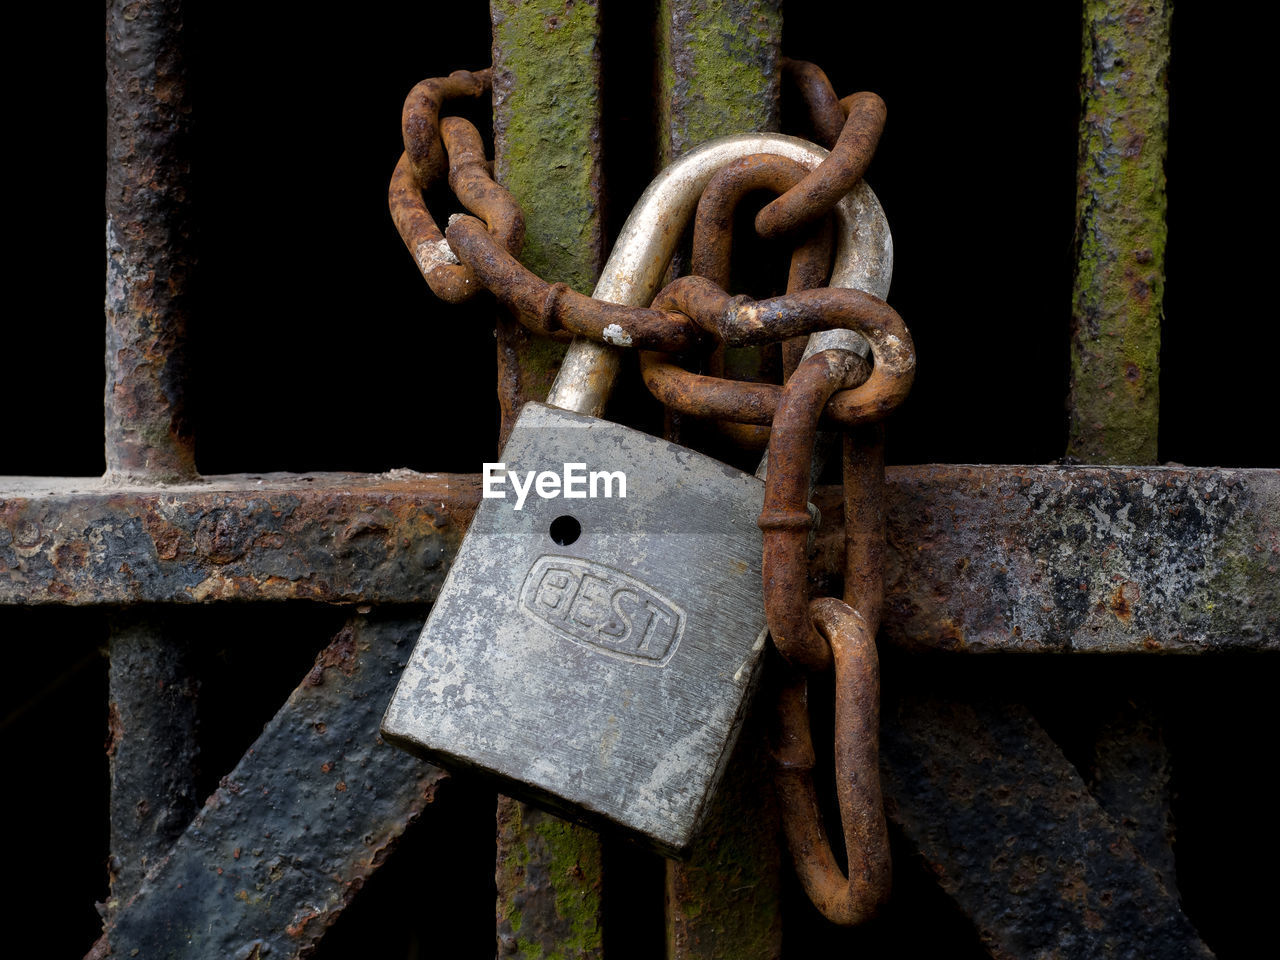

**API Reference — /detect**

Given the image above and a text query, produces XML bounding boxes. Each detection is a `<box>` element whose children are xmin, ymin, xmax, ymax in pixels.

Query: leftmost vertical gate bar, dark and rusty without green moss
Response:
<box><xmin>105</xmin><ymin>0</ymin><xmax>197</xmax><ymax>914</ymax></box>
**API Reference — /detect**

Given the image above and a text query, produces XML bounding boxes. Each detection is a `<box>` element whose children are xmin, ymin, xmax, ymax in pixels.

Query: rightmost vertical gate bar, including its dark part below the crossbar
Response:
<box><xmin>1068</xmin><ymin>0</ymin><xmax>1175</xmax><ymax>892</ymax></box>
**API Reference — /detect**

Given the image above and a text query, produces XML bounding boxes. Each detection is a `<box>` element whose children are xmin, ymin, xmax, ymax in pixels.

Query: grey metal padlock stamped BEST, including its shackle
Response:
<box><xmin>383</xmin><ymin>134</ymin><xmax>888</xmax><ymax>856</ymax></box>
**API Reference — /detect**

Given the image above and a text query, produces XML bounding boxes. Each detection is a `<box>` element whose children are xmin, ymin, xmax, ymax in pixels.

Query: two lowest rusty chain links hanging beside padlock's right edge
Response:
<box><xmin>759</xmin><ymin>343</ymin><xmax>910</xmax><ymax>925</ymax></box>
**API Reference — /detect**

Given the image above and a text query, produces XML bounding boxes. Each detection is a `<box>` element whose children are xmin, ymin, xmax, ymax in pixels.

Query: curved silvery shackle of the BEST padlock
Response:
<box><xmin>547</xmin><ymin>133</ymin><xmax>893</xmax><ymax>416</ymax></box>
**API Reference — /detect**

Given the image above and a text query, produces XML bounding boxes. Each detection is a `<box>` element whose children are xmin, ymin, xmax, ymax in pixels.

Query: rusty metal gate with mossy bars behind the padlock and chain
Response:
<box><xmin>0</xmin><ymin>0</ymin><xmax>1280</xmax><ymax>960</ymax></box>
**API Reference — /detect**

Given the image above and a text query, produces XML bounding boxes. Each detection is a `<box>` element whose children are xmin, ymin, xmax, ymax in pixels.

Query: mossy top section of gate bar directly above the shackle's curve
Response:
<box><xmin>658</xmin><ymin>0</ymin><xmax>782</xmax><ymax>164</ymax></box>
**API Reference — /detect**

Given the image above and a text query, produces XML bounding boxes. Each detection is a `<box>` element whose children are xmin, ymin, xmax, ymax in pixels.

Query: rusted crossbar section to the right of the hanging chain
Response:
<box><xmin>849</xmin><ymin>466</ymin><xmax>1280</xmax><ymax>653</ymax></box>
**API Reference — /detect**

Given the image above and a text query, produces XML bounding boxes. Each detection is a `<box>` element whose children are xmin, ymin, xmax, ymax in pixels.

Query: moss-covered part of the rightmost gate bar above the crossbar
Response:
<box><xmin>1068</xmin><ymin>0</ymin><xmax>1171</xmax><ymax>463</ymax></box>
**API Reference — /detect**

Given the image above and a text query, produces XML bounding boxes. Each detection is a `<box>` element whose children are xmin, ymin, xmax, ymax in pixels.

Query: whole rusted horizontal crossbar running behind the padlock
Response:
<box><xmin>0</xmin><ymin>466</ymin><xmax>1280</xmax><ymax>653</ymax></box>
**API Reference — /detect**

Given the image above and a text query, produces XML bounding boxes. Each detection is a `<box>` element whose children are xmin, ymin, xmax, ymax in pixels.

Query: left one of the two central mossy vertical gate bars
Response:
<box><xmin>489</xmin><ymin>0</ymin><xmax>602</xmax><ymax>960</ymax></box>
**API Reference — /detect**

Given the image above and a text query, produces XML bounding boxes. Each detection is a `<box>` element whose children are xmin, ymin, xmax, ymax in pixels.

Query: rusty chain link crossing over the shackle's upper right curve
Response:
<box><xmin>755</xmin><ymin>92</ymin><xmax>887</xmax><ymax>237</ymax></box>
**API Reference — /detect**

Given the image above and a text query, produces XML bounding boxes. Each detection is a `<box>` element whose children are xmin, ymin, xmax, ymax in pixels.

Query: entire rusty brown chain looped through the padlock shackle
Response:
<box><xmin>389</xmin><ymin>58</ymin><xmax>915</xmax><ymax>924</ymax></box>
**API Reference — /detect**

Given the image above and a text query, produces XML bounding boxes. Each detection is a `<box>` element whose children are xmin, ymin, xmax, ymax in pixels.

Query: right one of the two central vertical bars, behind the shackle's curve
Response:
<box><xmin>658</xmin><ymin>0</ymin><xmax>782</xmax><ymax>960</ymax></box>
